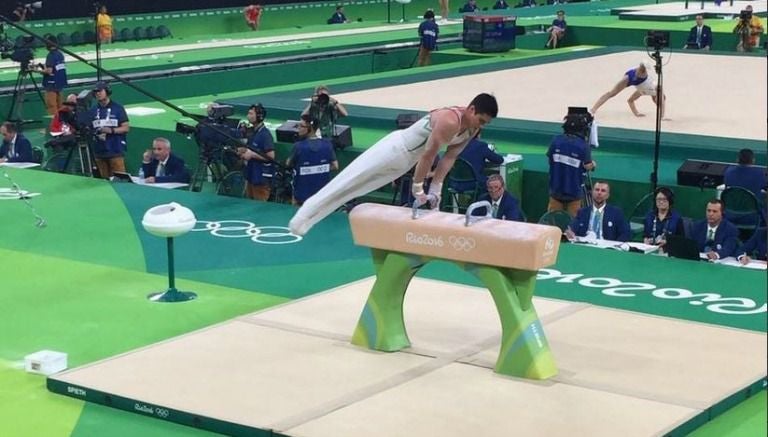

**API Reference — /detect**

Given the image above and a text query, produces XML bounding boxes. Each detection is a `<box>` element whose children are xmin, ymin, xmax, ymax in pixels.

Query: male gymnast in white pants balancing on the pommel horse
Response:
<box><xmin>289</xmin><ymin>93</ymin><xmax>499</xmax><ymax>235</ymax></box>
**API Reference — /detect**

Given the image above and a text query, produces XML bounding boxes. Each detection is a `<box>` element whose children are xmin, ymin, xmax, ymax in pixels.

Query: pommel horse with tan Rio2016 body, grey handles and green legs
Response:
<box><xmin>349</xmin><ymin>202</ymin><xmax>561</xmax><ymax>379</ymax></box>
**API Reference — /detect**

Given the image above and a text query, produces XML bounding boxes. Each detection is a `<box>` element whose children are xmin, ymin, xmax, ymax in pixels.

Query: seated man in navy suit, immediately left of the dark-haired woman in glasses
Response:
<box><xmin>566</xmin><ymin>182</ymin><xmax>630</xmax><ymax>241</ymax></box>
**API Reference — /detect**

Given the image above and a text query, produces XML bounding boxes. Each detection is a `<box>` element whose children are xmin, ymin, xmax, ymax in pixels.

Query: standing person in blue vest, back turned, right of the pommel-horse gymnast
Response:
<box><xmin>547</xmin><ymin>113</ymin><xmax>596</xmax><ymax>217</ymax></box>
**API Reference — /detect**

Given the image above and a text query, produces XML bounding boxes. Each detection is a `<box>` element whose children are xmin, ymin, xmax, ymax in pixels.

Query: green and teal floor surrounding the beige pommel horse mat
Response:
<box><xmin>0</xmin><ymin>170</ymin><xmax>766</xmax><ymax>436</ymax></box>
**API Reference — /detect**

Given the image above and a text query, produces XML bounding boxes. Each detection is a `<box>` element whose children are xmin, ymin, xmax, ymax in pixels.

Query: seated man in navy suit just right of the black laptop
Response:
<box><xmin>691</xmin><ymin>199</ymin><xmax>739</xmax><ymax>261</ymax></box>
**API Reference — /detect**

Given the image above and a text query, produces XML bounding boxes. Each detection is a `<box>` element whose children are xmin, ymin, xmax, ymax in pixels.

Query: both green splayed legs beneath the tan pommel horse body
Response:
<box><xmin>352</xmin><ymin>249</ymin><xmax>557</xmax><ymax>379</ymax></box>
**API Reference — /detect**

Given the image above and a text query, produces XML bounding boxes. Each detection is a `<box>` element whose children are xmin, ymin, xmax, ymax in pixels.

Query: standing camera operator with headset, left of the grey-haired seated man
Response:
<box><xmin>89</xmin><ymin>81</ymin><xmax>130</xmax><ymax>179</ymax></box>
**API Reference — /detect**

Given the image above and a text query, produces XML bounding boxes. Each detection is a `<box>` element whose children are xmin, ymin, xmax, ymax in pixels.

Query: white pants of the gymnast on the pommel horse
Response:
<box><xmin>289</xmin><ymin>130</ymin><xmax>424</xmax><ymax>235</ymax></box>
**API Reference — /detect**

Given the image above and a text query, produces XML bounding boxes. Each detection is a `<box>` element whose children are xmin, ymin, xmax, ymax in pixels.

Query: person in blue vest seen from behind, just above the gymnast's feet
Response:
<box><xmin>286</xmin><ymin>115</ymin><xmax>339</xmax><ymax>205</ymax></box>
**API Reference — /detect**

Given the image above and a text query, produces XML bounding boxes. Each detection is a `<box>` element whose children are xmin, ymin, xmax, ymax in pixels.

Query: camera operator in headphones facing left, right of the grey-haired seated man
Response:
<box><xmin>237</xmin><ymin>103</ymin><xmax>275</xmax><ymax>201</ymax></box>
